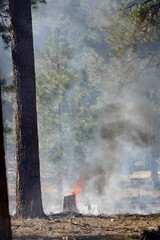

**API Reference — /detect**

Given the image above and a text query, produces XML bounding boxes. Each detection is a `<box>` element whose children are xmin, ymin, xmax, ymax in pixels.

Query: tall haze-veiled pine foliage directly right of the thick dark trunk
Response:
<box><xmin>36</xmin><ymin>28</ymin><xmax>76</xmax><ymax>171</ymax></box>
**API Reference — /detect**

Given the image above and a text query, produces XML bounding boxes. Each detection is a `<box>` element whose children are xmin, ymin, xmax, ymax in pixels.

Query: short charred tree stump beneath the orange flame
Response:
<box><xmin>63</xmin><ymin>194</ymin><xmax>79</xmax><ymax>213</ymax></box>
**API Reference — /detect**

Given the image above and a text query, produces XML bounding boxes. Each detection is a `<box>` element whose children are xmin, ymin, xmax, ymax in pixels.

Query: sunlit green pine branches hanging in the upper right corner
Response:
<box><xmin>106</xmin><ymin>0</ymin><xmax>160</xmax><ymax>57</ymax></box>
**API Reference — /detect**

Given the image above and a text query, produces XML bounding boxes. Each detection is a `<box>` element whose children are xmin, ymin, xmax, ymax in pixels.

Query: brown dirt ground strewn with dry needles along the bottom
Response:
<box><xmin>12</xmin><ymin>214</ymin><xmax>160</xmax><ymax>240</ymax></box>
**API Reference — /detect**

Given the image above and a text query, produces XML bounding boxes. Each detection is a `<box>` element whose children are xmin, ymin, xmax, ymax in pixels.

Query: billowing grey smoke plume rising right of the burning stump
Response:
<box><xmin>77</xmin><ymin>88</ymin><xmax>158</xmax><ymax>214</ymax></box>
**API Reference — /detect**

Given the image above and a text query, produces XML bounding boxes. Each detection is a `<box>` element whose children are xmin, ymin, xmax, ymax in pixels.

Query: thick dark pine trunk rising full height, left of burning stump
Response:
<box><xmin>9</xmin><ymin>0</ymin><xmax>44</xmax><ymax>218</ymax></box>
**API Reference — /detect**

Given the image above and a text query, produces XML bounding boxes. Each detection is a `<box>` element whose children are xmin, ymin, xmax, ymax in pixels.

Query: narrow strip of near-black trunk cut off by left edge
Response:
<box><xmin>0</xmin><ymin>86</ymin><xmax>12</xmax><ymax>240</ymax></box>
